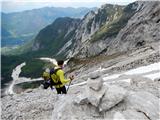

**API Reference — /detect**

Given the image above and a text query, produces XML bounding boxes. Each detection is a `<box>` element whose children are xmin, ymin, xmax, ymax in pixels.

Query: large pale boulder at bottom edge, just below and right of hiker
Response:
<box><xmin>52</xmin><ymin>95</ymin><xmax>99</xmax><ymax>120</ymax></box>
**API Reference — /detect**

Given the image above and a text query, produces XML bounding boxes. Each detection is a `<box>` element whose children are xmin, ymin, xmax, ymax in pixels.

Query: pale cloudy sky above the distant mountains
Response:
<box><xmin>1</xmin><ymin>0</ymin><xmax>136</xmax><ymax>13</ymax></box>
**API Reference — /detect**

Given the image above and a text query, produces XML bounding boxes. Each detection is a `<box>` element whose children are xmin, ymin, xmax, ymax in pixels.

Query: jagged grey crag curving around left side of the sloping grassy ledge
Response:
<box><xmin>68</xmin><ymin>4</ymin><xmax>123</xmax><ymax>58</ymax></box>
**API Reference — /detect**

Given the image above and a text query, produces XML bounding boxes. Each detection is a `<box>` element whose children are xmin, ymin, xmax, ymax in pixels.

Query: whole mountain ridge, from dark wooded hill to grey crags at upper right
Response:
<box><xmin>32</xmin><ymin>1</ymin><xmax>160</xmax><ymax>58</ymax></box>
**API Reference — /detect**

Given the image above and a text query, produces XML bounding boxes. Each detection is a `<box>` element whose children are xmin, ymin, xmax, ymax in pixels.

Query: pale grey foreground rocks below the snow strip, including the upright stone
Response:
<box><xmin>2</xmin><ymin>62</ymin><xmax>160</xmax><ymax>120</ymax></box>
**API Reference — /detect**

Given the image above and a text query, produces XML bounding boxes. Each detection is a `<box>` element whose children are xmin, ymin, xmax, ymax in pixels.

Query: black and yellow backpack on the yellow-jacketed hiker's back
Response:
<box><xmin>50</xmin><ymin>68</ymin><xmax>62</xmax><ymax>86</ymax></box>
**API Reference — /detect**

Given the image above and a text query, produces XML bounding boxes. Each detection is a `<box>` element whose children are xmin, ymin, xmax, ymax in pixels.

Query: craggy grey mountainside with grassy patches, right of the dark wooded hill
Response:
<box><xmin>70</xmin><ymin>1</ymin><xmax>160</xmax><ymax>58</ymax></box>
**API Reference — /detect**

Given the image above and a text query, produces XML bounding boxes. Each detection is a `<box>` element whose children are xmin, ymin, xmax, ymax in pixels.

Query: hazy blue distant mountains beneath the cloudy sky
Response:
<box><xmin>1</xmin><ymin>7</ymin><xmax>96</xmax><ymax>46</ymax></box>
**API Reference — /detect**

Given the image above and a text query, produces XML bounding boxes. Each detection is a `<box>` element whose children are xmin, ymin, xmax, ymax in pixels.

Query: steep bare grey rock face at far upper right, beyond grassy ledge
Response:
<box><xmin>108</xmin><ymin>1</ymin><xmax>160</xmax><ymax>54</ymax></box>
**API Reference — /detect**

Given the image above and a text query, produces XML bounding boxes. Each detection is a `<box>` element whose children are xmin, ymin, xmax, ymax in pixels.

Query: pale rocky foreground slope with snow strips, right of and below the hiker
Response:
<box><xmin>2</xmin><ymin>45</ymin><xmax>160</xmax><ymax>120</ymax></box>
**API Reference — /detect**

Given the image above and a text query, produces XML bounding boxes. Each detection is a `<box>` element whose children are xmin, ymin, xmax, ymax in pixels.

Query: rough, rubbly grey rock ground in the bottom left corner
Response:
<box><xmin>1</xmin><ymin>89</ymin><xmax>55</xmax><ymax>120</ymax></box>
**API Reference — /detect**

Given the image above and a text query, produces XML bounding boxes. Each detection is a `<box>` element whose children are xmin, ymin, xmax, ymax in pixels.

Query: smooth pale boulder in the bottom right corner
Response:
<box><xmin>125</xmin><ymin>92</ymin><xmax>160</xmax><ymax>120</ymax></box>
